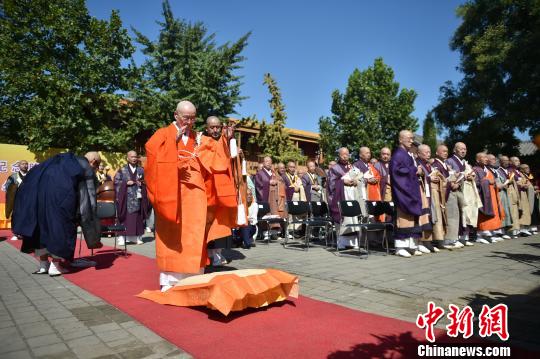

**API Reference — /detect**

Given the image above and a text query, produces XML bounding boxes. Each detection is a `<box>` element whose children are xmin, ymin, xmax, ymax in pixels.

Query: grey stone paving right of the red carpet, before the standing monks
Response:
<box><xmin>120</xmin><ymin>235</ymin><xmax>540</xmax><ymax>350</ymax></box>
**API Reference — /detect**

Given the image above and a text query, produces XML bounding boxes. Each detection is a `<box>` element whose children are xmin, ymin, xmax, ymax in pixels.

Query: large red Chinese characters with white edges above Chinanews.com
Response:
<box><xmin>416</xmin><ymin>302</ymin><xmax>510</xmax><ymax>343</ymax></box>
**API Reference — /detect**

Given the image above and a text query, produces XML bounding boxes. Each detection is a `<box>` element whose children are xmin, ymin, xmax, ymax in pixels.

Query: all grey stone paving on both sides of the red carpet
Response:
<box><xmin>0</xmin><ymin>236</ymin><xmax>540</xmax><ymax>358</ymax></box>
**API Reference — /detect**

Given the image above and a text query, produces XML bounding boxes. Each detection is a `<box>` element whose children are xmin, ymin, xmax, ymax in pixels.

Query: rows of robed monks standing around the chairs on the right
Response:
<box><xmin>253</xmin><ymin>130</ymin><xmax>540</xmax><ymax>257</ymax></box>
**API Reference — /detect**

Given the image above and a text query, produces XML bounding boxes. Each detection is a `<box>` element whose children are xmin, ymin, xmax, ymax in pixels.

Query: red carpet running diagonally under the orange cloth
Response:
<box><xmin>4</xmin><ymin>241</ymin><xmax>532</xmax><ymax>358</ymax></box>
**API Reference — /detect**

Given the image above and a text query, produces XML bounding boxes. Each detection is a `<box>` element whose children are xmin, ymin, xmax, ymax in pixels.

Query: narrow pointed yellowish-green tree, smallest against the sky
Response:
<box><xmin>250</xmin><ymin>74</ymin><xmax>305</xmax><ymax>162</ymax></box>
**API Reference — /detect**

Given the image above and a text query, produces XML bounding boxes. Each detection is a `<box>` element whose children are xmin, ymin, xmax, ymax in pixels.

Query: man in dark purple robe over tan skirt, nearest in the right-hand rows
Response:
<box><xmin>390</xmin><ymin>130</ymin><xmax>422</xmax><ymax>258</ymax></box>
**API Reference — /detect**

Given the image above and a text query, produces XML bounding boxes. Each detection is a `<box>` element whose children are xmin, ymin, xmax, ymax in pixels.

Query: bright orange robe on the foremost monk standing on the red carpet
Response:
<box><xmin>145</xmin><ymin>124</ymin><xmax>236</xmax><ymax>273</ymax></box>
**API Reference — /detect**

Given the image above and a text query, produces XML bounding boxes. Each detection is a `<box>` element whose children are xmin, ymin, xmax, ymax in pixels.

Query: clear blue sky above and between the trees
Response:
<box><xmin>87</xmin><ymin>0</ymin><xmax>463</xmax><ymax>132</ymax></box>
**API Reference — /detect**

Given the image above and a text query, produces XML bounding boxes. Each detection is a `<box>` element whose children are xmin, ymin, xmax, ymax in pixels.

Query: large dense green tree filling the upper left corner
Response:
<box><xmin>0</xmin><ymin>0</ymin><xmax>134</xmax><ymax>151</ymax></box>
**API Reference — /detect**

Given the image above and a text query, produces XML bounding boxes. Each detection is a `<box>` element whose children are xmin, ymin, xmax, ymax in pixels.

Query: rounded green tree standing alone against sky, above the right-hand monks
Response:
<box><xmin>319</xmin><ymin>58</ymin><xmax>418</xmax><ymax>161</ymax></box>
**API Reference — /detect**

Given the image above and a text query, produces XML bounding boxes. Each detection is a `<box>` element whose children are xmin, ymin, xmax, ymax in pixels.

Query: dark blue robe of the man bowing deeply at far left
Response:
<box><xmin>12</xmin><ymin>153</ymin><xmax>99</xmax><ymax>260</ymax></box>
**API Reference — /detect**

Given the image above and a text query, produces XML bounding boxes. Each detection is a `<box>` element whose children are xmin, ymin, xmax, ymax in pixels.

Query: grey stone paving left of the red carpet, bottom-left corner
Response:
<box><xmin>0</xmin><ymin>243</ymin><xmax>190</xmax><ymax>359</ymax></box>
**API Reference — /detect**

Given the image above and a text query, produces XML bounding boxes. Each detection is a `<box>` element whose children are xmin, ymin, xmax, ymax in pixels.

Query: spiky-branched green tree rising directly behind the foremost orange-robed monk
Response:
<box><xmin>131</xmin><ymin>0</ymin><xmax>250</xmax><ymax>136</ymax></box>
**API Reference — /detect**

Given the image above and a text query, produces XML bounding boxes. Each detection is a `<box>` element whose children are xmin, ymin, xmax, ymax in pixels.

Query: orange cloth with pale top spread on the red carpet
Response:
<box><xmin>137</xmin><ymin>269</ymin><xmax>298</xmax><ymax>315</ymax></box>
